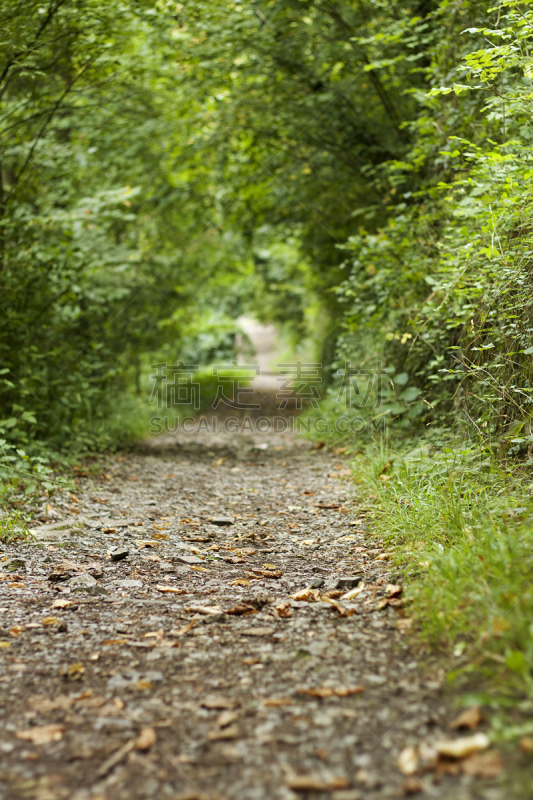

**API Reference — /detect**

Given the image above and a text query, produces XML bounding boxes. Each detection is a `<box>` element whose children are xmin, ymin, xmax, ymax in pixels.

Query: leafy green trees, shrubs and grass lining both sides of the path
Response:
<box><xmin>0</xmin><ymin>0</ymin><xmax>533</xmax><ymax>708</ymax></box>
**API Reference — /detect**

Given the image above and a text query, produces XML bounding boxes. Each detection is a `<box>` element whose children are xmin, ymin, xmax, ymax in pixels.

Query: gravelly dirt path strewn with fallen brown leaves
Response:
<box><xmin>0</xmin><ymin>404</ymin><xmax>492</xmax><ymax>800</ymax></box>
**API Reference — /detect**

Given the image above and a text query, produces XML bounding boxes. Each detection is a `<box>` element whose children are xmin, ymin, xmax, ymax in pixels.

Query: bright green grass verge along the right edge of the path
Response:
<box><xmin>354</xmin><ymin>445</ymin><xmax>533</xmax><ymax>697</ymax></box>
